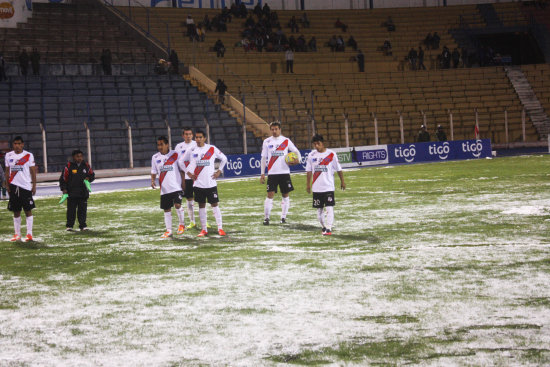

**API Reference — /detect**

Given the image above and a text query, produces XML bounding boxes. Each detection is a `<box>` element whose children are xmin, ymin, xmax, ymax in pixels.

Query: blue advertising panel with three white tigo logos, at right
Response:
<box><xmin>388</xmin><ymin>139</ymin><xmax>491</xmax><ymax>164</ymax></box>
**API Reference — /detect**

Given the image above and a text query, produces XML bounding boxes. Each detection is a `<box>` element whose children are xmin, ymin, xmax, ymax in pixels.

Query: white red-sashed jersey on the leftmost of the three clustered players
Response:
<box><xmin>151</xmin><ymin>150</ymin><xmax>182</xmax><ymax>195</ymax></box>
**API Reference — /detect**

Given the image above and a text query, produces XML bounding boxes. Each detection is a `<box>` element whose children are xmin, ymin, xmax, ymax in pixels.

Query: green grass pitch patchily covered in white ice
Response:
<box><xmin>0</xmin><ymin>156</ymin><xmax>550</xmax><ymax>366</ymax></box>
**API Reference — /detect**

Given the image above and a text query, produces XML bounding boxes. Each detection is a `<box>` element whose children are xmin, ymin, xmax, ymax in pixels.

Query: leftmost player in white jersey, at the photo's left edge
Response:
<box><xmin>5</xmin><ymin>136</ymin><xmax>37</xmax><ymax>242</ymax></box>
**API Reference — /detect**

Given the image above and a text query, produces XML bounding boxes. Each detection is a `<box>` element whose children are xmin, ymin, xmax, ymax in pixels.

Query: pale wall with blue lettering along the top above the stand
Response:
<box><xmin>92</xmin><ymin>0</ymin><xmax>513</xmax><ymax>10</ymax></box>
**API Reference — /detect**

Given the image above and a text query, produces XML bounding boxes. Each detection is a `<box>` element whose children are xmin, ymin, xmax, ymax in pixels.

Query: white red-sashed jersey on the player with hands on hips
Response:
<box><xmin>187</xmin><ymin>144</ymin><xmax>227</xmax><ymax>189</ymax></box>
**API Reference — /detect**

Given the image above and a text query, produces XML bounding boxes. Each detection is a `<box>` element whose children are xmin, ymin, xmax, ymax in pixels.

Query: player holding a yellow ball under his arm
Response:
<box><xmin>260</xmin><ymin>122</ymin><xmax>302</xmax><ymax>225</ymax></box>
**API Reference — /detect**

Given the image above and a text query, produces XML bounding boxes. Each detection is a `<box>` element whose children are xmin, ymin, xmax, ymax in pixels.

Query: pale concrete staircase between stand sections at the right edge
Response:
<box><xmin>505</xmin><ymin>66</ymin><xmax>550</xmax><ymax>140</ymax></box>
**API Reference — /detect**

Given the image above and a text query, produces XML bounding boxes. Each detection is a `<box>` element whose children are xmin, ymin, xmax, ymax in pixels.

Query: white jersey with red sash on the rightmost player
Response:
<box><xmin>306</xmin><ymin>149</ymin><xmax>342</xmax><ymax>192</ymax></box>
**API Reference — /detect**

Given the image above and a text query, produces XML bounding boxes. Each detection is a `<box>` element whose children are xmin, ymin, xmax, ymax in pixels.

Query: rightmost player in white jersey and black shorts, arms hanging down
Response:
<box><xmin>306</xmin><ymin>134</ymin><xmax>346</xmax><ymax>236</ymax></box>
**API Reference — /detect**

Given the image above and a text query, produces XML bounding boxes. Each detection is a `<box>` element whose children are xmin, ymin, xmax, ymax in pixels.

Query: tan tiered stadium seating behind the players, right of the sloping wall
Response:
<box><xmin>127</xmin><ymin>5</ymin><xmax>539</xmax><ymax>146</ymax></box>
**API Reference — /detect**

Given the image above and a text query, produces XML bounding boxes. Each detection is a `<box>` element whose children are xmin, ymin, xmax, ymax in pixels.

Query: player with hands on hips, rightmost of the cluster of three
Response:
<box><xmin>187</xmin><ymin>130</ymin><xmax>227</xmax><ymax>237</ymax></box>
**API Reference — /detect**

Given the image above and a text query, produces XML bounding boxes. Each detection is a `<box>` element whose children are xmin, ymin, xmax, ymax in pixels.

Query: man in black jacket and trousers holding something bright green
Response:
<box><xmin>59</xmin><ymin>149</ymin><xmax>95</xmax><ymax>231</ymax></box>
